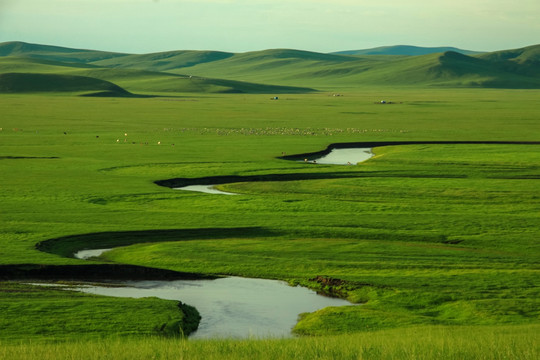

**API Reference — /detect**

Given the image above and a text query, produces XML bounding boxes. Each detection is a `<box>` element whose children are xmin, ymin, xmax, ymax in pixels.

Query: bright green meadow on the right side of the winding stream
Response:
<box><xmin>92</xmin><ymin>145</ymin><xmax>540</xmax><ymax>333</ymax></box>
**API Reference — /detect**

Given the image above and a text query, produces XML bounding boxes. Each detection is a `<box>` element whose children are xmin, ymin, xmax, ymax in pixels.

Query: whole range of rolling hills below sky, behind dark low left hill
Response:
<box><xmin>0</xmin><ymin>42</ymin><xmax>540</xmax><ymax>93</ymax></box>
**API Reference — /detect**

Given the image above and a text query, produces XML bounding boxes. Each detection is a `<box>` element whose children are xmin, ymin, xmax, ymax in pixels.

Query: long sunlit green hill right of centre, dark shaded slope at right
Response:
<box><xmin>165</xmin><ymin>47</ymin><xmax>540</xmax><ymax>88</ymax></box>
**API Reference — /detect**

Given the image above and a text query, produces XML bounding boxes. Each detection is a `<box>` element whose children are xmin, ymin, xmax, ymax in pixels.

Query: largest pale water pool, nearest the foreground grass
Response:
<box><xmin>71</xmin><ymin>277</ymin><xmax>353</xmax><ymax>339</ymax></box>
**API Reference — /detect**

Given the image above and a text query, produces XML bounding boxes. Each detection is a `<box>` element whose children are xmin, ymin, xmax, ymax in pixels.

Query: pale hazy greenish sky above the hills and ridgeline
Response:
<box><xmin>0</xmin><ymin>0</ymin><xmax>540</xmax><ymax>53</ymax></box>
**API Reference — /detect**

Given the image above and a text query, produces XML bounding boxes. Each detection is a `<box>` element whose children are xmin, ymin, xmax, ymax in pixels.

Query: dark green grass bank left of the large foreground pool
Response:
<box><xmin>0</xmin><ymin>282</ymin><xmax>198</xmax><ymax>340</ymax></box>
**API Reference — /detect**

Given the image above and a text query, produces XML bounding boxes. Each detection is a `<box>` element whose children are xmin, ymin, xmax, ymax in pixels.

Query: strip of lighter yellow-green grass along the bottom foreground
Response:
<box><xmin>0</xmin><ymin>326</ymin><xmax>539</xmax><ymax>360</ymax></box>
